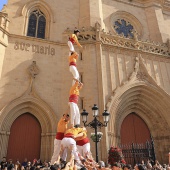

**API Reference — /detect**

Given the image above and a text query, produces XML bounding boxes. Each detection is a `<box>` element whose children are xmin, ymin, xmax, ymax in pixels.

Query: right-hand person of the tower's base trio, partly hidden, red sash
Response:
<box><xmin>75</xmin><ymin>131</ymin><xmax>91</xmax><ymax>157</ymax></box>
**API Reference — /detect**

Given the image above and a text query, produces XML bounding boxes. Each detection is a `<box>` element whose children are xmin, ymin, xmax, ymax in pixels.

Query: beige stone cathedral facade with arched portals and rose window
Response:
<box><xmin>0</xmin><ymin>0</ymin><xmax>170</xmax><ymax>162</ymax></box>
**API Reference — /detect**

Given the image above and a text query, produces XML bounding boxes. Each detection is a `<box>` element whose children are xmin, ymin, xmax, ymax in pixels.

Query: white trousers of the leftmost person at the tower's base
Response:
<box><xmin>51</xmin><ymin>139</ymin><xmax>67</xmax><ymax>165</ymax></box>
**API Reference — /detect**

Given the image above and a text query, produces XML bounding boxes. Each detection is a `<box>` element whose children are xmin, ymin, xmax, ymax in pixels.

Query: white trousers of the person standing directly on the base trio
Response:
<box><xmin>69</xmin><ymin>102</ymin><xmax>80</xmax><ymax>125</ymax></box>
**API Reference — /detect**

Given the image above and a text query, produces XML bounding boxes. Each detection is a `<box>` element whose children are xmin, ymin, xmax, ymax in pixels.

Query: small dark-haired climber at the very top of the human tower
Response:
<box><xmin>67</xmin><ymin>29</ymin><xmax>82</xmax><ymax>53</ymax></box>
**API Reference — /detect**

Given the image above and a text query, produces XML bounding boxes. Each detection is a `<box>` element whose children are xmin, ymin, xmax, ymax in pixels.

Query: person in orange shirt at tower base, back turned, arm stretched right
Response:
<box><xmin>60</xmin><ymin>127</ymin><xmax>86</xmax><ymax>163</ymax></box>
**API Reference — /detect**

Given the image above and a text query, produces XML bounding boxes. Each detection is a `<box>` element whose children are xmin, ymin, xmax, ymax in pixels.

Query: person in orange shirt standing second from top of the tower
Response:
<box><xmin>69</xmin><ymin>52</ymin><xmax>79</xmax><ymax>85</ymax></box>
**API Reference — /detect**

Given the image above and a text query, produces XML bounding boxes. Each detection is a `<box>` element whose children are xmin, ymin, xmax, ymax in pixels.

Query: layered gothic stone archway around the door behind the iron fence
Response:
<box><xmin>107</xmin><ymin>81</ymin><xmax>170</xmax><ymax>162</ymax></box>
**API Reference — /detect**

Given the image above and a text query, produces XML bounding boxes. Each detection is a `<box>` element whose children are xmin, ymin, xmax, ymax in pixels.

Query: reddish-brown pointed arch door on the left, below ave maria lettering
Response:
<box><xmin>7</xmin><ymin>113</ymin><xmax>41</xmax><ymax>162</ymax></box>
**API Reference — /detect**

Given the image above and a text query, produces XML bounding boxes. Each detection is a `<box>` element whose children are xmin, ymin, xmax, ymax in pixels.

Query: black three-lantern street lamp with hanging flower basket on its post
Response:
<box><xmin>81</xmin><ymin>104</ymin><xmax>110</xmax><ymax>162</ymax></box>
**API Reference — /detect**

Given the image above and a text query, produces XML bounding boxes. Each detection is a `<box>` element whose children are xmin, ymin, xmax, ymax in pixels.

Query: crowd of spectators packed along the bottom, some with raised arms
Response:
<box><xmin>0</xmin><ymin>155</ymin><xmax>170</xmax><ymax>170</ymax></box>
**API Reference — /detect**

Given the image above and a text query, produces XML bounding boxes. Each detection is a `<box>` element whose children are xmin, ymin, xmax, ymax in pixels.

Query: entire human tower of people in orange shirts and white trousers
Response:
<box><xmin>51</xmin><ymin>29</ymin><xmax>90</xmax><ymax>165</ymax></box>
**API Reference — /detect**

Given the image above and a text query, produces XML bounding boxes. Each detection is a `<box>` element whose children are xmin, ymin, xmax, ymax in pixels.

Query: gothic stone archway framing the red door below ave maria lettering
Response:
<box><xmin>0</xmin><ymin>95</ymin><xmax>56</xmax><ymax>160</ymax></box>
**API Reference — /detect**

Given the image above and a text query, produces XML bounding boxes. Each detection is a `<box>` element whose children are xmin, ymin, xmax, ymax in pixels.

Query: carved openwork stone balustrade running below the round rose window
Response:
<box><xmin>63</xmin><ymin>23</ymin><xmax>170</xmax><ymax>57</ymax></box>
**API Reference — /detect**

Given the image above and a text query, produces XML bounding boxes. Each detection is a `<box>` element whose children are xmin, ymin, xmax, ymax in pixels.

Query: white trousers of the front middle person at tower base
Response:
<box><xmin>61</xmin><ymin>137</ymin><xmax>80</xmax><ymax>161</ymax></box>
